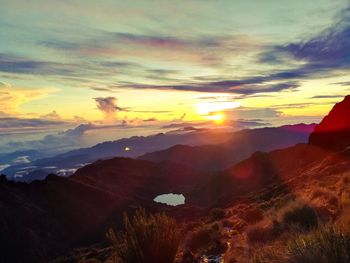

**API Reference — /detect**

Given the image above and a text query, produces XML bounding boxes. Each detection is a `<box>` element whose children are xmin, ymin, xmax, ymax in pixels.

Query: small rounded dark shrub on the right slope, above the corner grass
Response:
<box><xmin>283</xmin><ymin>205</ymin><xmax>318</xmax><ymax>231</ymax></box>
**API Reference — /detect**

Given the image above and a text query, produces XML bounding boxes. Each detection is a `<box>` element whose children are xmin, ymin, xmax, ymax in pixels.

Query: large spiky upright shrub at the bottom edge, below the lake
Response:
<box><xmin>107</xmin><ymin>209</ymin><xmax>180</xmax><ymax>263</ymax></box>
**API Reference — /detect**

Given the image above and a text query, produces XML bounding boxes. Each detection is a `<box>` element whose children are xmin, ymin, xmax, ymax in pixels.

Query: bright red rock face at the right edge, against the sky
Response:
<box><xmin>309</xmin><ymin>95</ymin><xmax>350</xmax><ymax>150</ymax></box>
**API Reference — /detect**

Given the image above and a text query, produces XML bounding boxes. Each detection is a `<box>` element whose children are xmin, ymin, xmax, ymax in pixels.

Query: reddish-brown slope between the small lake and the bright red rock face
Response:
<box><xmin>188</xmin><ymin>144</ymin><xmax>332</xmax><ymax>207</ymax></box>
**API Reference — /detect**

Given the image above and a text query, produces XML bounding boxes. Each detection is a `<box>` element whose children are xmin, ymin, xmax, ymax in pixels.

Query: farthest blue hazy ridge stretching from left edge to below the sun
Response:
<box><xmin>0</xmin><ymin>130</ymin><xmax>233</xmax><ymax>182</ymax></box>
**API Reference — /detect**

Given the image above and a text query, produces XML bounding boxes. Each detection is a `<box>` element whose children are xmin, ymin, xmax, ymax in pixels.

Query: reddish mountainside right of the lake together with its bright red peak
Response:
<box><xmin>189</xmin><ymin>96</ymin><xmax>350</xmax><ymax>206</ymax></box>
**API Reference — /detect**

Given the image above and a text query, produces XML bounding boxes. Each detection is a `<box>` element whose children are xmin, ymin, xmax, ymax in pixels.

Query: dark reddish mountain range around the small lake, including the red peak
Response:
<box><xmin>0</xmin><ymin>97</ymin><xmax>350</xmax><ymax>262</ymax></box>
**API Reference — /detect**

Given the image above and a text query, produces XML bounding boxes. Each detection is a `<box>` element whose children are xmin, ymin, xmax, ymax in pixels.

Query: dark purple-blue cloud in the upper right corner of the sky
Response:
<box><xmin>260</xmin><ymin>7</ymin><xmax>350</xmax><ymax>79</ymax></box>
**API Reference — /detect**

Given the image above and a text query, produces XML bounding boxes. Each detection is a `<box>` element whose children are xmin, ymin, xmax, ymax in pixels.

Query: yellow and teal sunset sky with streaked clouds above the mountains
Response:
<box><xmin>0</xmin><ymin>0</ymin><xmax>350</xmax><ymax>155</ymax></box>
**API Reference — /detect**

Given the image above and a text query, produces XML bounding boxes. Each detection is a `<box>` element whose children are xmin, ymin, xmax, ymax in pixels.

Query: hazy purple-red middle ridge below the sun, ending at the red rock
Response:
<box><xmin>139</xmin><ymin>124</ymin><xmax>315</xmax><ymax>171</ymax></box>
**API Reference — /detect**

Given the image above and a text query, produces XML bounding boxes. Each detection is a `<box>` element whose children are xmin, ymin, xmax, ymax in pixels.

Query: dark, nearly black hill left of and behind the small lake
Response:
<box><xmin>0</xmin><ymin>158</ymin><xmax>200</xmax><ymax>262</ymax></box>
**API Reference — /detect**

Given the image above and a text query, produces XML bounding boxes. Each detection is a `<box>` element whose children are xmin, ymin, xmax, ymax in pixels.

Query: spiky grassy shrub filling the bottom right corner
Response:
<box><xmin>288</xmin><ymin>226</ymin><xmax>350</xmax><ymax>263</ymax></box>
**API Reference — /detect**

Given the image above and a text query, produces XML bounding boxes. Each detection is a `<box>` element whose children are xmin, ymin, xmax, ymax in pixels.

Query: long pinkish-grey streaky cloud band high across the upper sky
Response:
<box><xmin>38</xmin><ymin>30</ymin><xmax>259</xmax><ymax>67</ymax></box>
